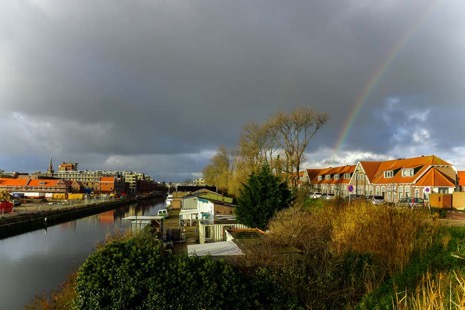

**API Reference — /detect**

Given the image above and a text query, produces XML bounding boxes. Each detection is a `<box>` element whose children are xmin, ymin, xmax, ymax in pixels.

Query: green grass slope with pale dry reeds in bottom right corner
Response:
<box><xmin>358</xmin><ymin>227</ymin><xmax>465</xmax><ymax>309</ymax></box>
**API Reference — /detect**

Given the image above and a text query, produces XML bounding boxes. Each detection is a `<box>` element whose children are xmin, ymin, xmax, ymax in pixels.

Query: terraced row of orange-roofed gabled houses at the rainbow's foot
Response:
<box><xmin>307</xmin><ymin>155</ymin><xmax>459</xmax><ymax>203</ymax></box>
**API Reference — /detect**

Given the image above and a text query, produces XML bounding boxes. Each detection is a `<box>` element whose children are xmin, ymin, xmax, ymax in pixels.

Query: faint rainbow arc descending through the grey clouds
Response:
<box><xmin>333</xmin><ymin>0</ymin><xmax>444</xmax><ymax>154</ymax></box>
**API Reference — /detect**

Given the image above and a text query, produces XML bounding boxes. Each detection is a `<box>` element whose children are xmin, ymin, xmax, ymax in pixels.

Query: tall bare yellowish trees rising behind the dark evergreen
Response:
<box><xmin>203</xmin><ymin>107</ymin><xmax>328</xmax><ymax>197</ymax></box>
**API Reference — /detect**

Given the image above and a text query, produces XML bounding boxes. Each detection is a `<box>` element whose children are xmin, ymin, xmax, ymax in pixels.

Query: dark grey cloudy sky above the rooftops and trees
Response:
<box><xmin>0</xmin><ymin>0</ymin><xmax>465</xmax><ymax>181</ymax></box>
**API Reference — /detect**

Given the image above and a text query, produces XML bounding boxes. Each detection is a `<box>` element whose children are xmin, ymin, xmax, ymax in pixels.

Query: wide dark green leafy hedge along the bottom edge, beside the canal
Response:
<box><xmin>76</xmin><ymin>229</ymin><xmax>245</xmax><ymax>309</ymax></box>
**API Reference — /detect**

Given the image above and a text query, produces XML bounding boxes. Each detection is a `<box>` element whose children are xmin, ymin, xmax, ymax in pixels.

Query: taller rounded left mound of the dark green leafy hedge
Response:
<box><xmin>77</xmin><ymin>229</ymin><xmax>161</xmax><ymax>309</ymax></box>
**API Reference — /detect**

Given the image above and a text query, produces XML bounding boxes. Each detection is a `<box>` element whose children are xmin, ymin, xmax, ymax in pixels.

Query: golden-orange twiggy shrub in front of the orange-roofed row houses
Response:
<box><xmin>332</xmin><ymin>203</ymin><xmax>439</xmax><ymax>275</ymax></box>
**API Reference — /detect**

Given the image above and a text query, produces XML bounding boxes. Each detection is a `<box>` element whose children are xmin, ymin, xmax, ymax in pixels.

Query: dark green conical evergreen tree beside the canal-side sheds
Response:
<box><xmin>235</xmin><ymin>164</ymin><xmax>291</xmax><ymax>229</ymax></box>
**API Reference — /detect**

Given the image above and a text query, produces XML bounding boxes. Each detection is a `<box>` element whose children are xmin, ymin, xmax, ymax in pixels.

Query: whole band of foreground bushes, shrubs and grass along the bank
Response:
<box><xmin>26</xmin><ymin>198</ymin><xmax>465</xmax><ymax>309</ymax></box>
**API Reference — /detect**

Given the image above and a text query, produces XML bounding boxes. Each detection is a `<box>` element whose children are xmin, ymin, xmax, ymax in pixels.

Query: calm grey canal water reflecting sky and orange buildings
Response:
<box><xmin>0</xmin><ymin>200</ymin><xmax>165</xmax><ymax>309</ymax></box>
